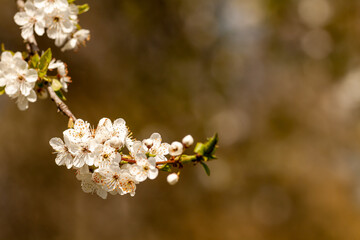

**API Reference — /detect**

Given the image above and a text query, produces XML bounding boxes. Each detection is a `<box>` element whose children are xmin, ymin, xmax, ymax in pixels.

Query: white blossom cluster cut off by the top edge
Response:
<box><xmin>14</xmin><ymin>0</ymin><xmax>90</xmax><ymax>51</ymax></box>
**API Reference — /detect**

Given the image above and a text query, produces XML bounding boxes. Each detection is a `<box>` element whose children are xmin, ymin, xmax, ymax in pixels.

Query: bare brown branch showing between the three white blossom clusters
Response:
<box><xmin>15</xmin><ymin>0</ymin><xmax>76</xmax><ymax>121</ymax></box>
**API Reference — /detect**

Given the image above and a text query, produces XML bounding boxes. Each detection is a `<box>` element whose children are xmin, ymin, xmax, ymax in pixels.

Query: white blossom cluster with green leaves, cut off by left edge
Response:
<box><xmin>0</xmin><ymin>51</ymin><xmax>71</xmax><ymax>111</ymax></box>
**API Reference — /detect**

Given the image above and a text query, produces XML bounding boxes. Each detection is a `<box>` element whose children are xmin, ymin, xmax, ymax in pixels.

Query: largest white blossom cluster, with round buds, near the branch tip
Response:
<box><xmin>49</xmin><ymin>118</ymin><xmax>193</xmax><ymax>199</ymax></box>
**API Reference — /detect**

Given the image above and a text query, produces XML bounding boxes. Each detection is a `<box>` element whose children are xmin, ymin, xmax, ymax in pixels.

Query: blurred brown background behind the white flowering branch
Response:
<box><xmin>0</xmin><ymin>0</ymin><xmax>360</xmax><ymax>240</ymax></box>
